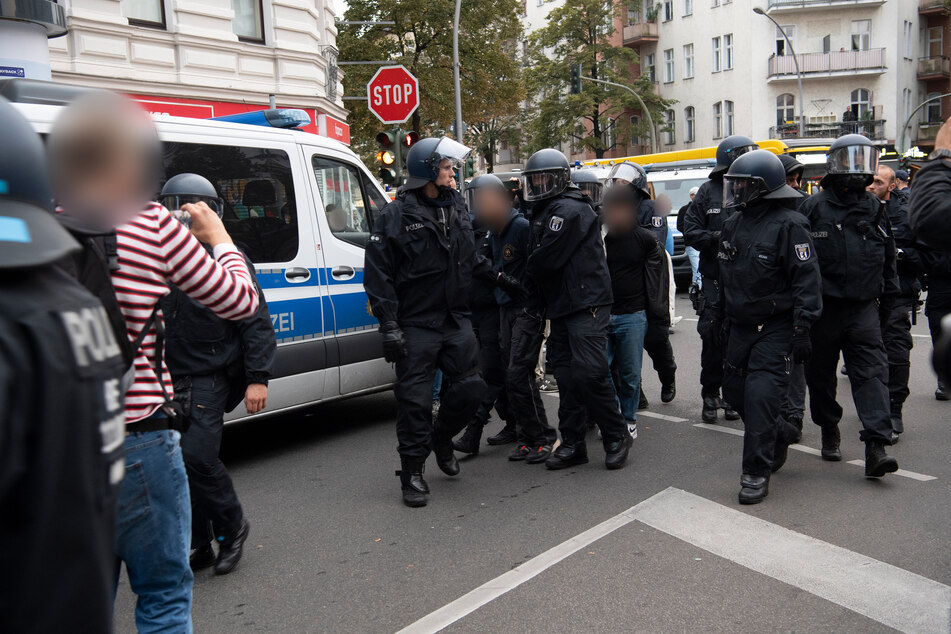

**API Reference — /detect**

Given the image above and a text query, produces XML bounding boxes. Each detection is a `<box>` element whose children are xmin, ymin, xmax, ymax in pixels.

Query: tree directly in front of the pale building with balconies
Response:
<box><xmin>526</xmin><ymin>0</ymin><xmax>673</xmax><ymax>158</ymax></box>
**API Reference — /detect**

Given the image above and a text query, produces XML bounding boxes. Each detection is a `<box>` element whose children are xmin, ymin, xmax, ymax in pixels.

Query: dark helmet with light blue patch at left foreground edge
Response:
<box><xmin>0</xmin><ymin>97</ymin><xmax>79</xmax><ymax>269</ymax></box>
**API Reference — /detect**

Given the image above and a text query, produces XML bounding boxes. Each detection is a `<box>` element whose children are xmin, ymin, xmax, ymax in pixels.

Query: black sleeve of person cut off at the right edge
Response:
<box><xmin>908</xmin><ymin>159</ymin><xmax>951</xmax><ymax>249</ymax></box>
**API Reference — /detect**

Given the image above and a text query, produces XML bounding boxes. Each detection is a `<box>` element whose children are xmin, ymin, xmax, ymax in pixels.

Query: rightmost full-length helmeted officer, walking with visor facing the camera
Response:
<box><xmin>799</xmin><ymin>134</ymin><xmax>899</xmax><ymax>478</ymax></box>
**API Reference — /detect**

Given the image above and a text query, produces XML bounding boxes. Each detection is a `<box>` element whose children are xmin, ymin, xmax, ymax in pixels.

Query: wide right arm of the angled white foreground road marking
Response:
<box><xmin>632</xmin><ymin>488</ymin><xmax>951</xmax><ymax>634</ymax></box>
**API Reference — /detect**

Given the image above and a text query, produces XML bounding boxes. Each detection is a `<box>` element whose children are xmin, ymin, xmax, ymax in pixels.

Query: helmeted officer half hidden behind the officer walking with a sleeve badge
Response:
<box><xmin>684</xmin><ymin>135</ymin><xmax>757</xmax><ymax>423</ymax></box>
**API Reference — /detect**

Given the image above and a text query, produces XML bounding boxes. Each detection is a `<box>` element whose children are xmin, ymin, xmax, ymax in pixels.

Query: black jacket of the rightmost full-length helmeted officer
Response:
<box><xmin>799</xmin><ymin>181</ymin><xmax>899</xmax><ymax>301</ymax></box>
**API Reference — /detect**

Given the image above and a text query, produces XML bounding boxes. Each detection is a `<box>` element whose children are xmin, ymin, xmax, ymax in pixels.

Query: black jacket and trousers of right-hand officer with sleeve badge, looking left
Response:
<box><xmin>720</xmin><ymin>200</ymin><xmax>822</xmax><ymax>478</ymax></box>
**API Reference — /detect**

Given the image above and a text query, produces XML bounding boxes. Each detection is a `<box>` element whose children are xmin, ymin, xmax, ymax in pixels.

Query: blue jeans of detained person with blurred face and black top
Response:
<box><xmin>608</xmin><ymin>310</ymin><xmax>647</xmax><ymax>421</ymax></box>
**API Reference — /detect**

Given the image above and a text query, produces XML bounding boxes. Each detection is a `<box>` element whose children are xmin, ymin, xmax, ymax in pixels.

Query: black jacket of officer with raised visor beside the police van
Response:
<box><xmin>363</xmin><ymin>189</ymin><xmax>492</xmax><ymax>328</ymax></box>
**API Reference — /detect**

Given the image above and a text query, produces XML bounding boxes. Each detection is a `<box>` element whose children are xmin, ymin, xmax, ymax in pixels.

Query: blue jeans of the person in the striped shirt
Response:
<box><xmin>116</xmin><ymin>424</ymin><xmax>194</xmax><ymax>634</ymax></box>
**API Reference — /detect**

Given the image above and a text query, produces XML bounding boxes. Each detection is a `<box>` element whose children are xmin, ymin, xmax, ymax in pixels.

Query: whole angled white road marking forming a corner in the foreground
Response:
<box><xmin>398</xmin><ymin>488</ymin><xmax>951</xmax><ymax>634</ymax></box>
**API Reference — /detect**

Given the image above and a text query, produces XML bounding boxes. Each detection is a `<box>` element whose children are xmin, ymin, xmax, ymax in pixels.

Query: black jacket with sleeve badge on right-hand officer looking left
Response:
<box><xmin>719</xmin><ymin>203</ymin><xmax>822</xmax><ymax>328</ymax></box>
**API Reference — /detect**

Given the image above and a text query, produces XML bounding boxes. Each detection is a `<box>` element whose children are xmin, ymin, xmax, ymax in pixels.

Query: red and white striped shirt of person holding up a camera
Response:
<box><xmin>112</xmin><ymin>204</ymin><xmax>259</xmax><ymax>423</ymax></box>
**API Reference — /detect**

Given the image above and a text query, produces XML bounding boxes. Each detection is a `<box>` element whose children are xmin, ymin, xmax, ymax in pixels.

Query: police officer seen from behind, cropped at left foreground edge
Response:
<box><xmin>0</xmin><ymin>97</ymin><xmax>125</xmax><ymax>632</ymax></box>
